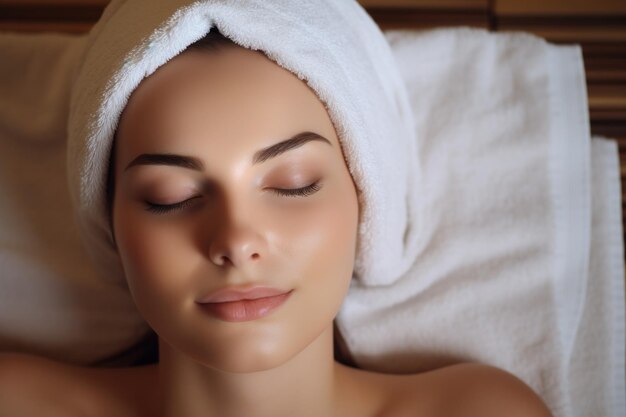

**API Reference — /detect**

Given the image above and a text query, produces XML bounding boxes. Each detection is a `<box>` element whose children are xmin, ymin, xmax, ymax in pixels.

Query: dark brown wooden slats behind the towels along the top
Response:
<box><xmin>0</xmin><ymin>0</ymin><xmax>626</xmax><ymax>240</ymax></box>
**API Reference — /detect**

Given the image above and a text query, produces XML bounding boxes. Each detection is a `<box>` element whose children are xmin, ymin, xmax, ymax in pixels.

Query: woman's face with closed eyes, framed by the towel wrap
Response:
<box><xmin>113</xmin><ymin>47</ymin><xmax>358</xmax><ymax>372</ymax></box>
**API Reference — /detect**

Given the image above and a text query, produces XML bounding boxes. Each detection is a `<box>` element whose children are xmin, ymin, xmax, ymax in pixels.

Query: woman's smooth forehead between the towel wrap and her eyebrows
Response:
<box><xmin>117</xmin><ymin>46</ymin><xmax>338</xmax><ymax>157</ymax></box>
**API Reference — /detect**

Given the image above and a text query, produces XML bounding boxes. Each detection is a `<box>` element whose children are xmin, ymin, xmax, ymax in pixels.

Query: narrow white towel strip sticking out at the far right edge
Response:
<box><xmin>567</xmin><ymin>137</ymin><xmax>626</xmax><ymax>417</ymax></box>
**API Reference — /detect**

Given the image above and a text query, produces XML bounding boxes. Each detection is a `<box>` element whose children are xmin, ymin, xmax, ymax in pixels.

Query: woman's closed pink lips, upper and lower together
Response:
<box><xmin>198</xmin><ymin>287</ymin><xmax>293</xmax><ymax>322</ymax></box>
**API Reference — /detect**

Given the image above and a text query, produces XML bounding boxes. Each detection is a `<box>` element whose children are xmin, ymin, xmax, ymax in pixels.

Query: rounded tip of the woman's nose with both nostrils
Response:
<box><xmin>208</xmin><ymin>219</ymin><xmax>266</xmax><ymax>268</ymax></box>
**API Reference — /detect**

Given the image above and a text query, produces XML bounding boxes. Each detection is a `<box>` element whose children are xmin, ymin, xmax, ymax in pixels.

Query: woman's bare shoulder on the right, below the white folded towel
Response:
<box><xmin>388</xmin><ymin>363</ymin><xmax>552</xmax><ymax>417</ymax></box>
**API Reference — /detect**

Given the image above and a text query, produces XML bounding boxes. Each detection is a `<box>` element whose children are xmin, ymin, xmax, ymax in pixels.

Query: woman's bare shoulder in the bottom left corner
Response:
<box><xmin>0</xmin><ymin>353</ymin><xmax>155</xmax><ymax>417</ymax></box>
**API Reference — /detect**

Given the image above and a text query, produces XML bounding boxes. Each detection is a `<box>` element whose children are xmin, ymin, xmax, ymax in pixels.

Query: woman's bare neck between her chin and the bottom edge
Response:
<box><xmin>159</xmin><ymin>327</ymin><xmax>340</xmax><ymax>417</ymax></box>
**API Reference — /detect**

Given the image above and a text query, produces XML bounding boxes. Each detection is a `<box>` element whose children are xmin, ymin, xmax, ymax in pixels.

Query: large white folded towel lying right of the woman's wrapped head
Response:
<box><xmin>338</xmin><ymin>29</ymin><xmax>625</xmax><ymax>417</ymax></box>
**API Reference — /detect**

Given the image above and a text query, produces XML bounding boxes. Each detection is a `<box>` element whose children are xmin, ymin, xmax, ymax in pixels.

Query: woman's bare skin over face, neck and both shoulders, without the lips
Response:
<box><xmin>0</xmin><ymin>47</ymin><xmax>550</xmax><ymax>417</ymax></box>
